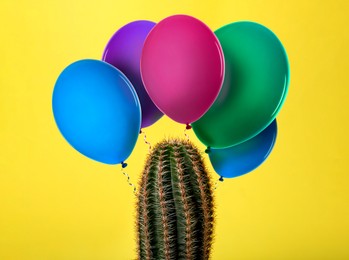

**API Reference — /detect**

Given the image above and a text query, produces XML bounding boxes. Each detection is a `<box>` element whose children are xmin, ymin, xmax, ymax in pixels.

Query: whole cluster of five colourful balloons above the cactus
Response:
<box><xmin>52</xmin><ymin>15</ymin><xmax>289</xmax><ymax>180</ymax></box>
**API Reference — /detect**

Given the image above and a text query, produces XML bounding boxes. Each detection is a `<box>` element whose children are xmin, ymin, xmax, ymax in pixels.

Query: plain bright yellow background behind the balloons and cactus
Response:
<box><xmin>0</xmin><ymin>0</ymin><xmax>349</xmax><ymax>260</ymax></box>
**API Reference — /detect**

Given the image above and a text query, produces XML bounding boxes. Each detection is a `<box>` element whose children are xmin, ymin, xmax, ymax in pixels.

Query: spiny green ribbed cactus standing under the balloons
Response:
<box><xmin>136</xmin><ymin>140</ymin><xmax>214</xmax><ymax>260</ymax></box>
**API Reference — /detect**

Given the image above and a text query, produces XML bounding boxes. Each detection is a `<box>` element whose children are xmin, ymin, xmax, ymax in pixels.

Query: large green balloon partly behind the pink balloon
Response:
<box><xmin>193</xmin><ymin>22</ymin><xmax>289</xmax><ymax>148</ymax></box>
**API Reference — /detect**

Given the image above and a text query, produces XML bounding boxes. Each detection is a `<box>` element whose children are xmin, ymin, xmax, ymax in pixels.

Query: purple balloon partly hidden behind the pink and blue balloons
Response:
<box><xmin>102</xmin><ymin>21</ymin><xmax>162</xmax><ymax>128</ymax></box>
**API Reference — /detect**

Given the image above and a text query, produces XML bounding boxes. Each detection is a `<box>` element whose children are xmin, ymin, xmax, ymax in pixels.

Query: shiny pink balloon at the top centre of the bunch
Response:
<box><xmin>141</xmin><ymin>15</ymin><xmax>224</xmax><ymax>124</ymax></box>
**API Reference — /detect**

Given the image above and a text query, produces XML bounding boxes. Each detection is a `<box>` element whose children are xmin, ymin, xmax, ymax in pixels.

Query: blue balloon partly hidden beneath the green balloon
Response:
<box><xmin>208</xmin><ymin>119</ymin><xmax>277</xmax><ymax>178</ymax></box>
